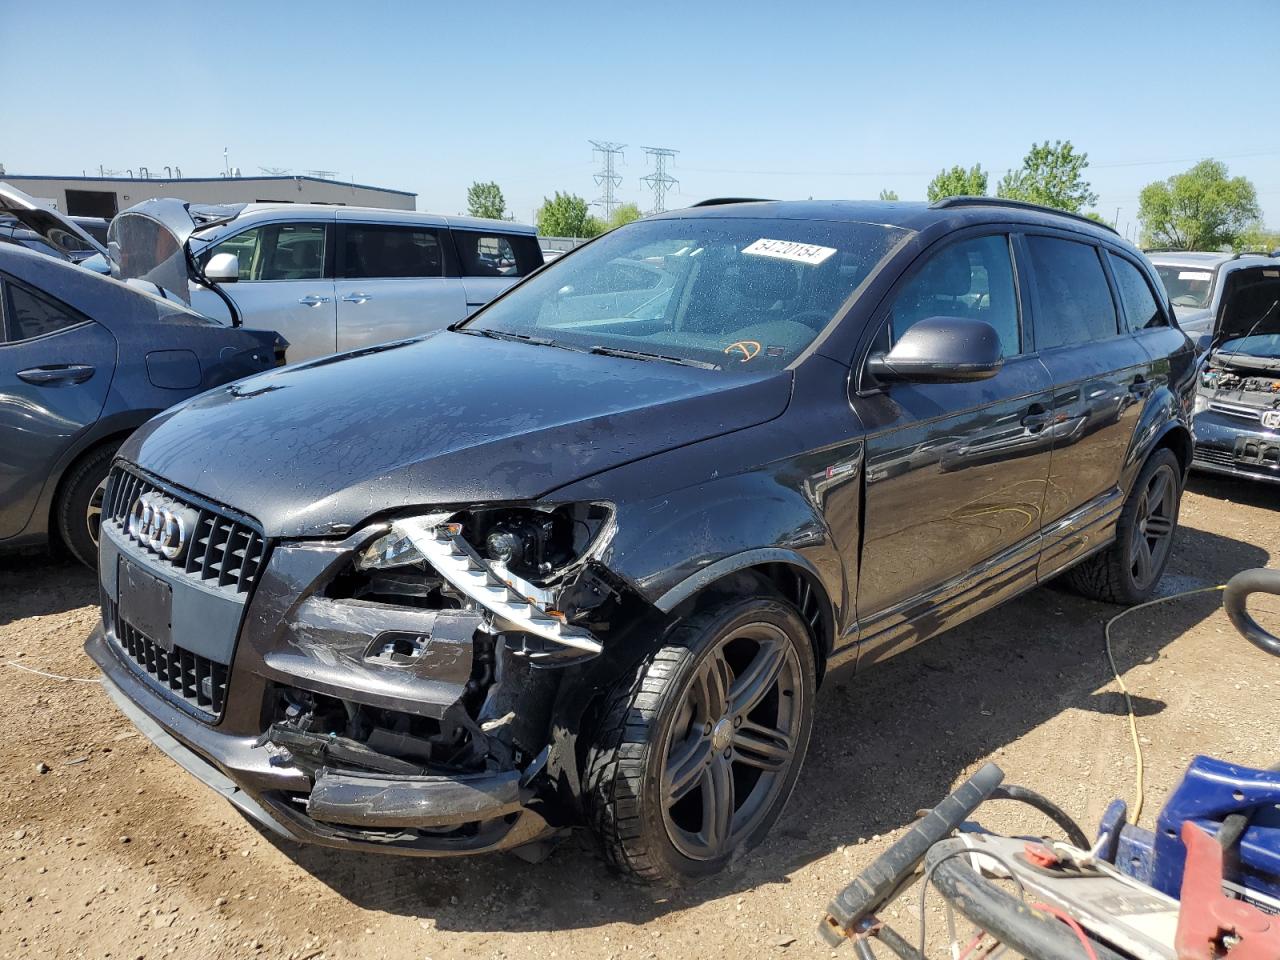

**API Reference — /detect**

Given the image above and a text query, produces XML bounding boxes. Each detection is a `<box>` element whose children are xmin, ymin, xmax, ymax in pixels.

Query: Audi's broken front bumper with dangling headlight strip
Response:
<box><xmin>86</xmin><ymin>488</ymin><xmax>629</xmax><ymax>856</ymax></box>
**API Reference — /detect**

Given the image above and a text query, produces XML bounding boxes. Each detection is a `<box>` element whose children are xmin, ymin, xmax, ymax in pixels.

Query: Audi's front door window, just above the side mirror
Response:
<box><xmin>890</xmin><ymin>234</ymin><xmax>1021</xmax><ymax>357</ymax></box>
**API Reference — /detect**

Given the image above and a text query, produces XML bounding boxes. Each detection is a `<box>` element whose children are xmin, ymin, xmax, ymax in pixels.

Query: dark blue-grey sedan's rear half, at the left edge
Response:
<box><xmin>0</xmin><ymin>244</ymin><xmax>285</xmax><ymax>566</ymax></box>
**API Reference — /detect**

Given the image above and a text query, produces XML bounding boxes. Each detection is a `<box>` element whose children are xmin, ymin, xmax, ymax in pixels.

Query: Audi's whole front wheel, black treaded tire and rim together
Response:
<box><xmin>584</xmin><ymin>598</ymin><xmax>817</xmax><ymax>884</ymax></box>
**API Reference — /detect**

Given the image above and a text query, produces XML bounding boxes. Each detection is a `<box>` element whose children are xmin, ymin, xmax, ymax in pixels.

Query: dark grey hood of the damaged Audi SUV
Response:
<box><xmin>122</xmin><ymin>332</ymin><xmax>791</xmax><ymax>538</ymax></box>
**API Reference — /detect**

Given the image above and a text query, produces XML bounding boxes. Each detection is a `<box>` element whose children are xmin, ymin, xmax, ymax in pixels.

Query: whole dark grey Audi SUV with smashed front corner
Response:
<box><xmin>87</xmin><ymin>198</ymin><xmax>1196</xmax><ymax>883</ymax></box>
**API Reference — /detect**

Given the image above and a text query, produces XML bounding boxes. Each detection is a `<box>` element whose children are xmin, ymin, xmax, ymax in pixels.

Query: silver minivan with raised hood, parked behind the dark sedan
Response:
<box><xmin>110</xmin><ymin>200</ymin><xmax>543</xmax><ymax>362</ymax></box>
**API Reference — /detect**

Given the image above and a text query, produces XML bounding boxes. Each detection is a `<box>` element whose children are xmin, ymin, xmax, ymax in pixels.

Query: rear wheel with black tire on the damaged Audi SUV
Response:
<box><xmin>1068</xmin><ymin>449</ymin><xmax>1183</xmax><ymax>605</ymax></box>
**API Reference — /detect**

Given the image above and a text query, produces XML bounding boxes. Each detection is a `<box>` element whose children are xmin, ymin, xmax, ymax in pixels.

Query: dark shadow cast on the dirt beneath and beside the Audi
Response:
<box><xmin>267</xmin><ymin>527</ymin><xmax>1268</xmax><ymax>931</ymax></box>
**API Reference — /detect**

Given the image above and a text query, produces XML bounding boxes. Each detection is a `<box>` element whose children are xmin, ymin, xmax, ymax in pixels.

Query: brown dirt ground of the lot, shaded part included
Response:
<box><xmin>0</xmin><ymin>479</ymin><xmax>1280</xmax><ymax>960</ymax></box>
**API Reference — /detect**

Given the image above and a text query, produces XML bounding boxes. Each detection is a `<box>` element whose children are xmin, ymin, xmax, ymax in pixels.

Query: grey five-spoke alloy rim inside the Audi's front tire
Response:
<box><xmin>662</xmin><ymin>623</ymin><xmax>804</xmax><ymax>860</ymax></box>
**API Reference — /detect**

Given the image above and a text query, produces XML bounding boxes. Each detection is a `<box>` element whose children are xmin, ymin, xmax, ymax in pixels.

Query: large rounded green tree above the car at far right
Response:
<box><xmin>1138</xmin><ymin>160</ymin><xmax>1261</xmax><ymax>250</ymax></box>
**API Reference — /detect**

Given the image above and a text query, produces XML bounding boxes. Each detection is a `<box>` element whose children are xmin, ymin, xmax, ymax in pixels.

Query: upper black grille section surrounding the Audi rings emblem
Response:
<box><xmin>102</xmin><ymin>467</ymin><xmax>266</xmax><ymax>593</ymax></box>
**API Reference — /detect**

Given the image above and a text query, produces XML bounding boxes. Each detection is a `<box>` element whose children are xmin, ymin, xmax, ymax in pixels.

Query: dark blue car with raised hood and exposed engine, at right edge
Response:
<box><xmin>1192</xmin><ymin>257</ymin><xmax>1280</xmax><ymax>483</ymax></box>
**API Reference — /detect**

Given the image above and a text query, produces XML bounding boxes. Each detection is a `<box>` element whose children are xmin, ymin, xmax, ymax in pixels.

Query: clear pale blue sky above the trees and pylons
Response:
<box><xmin>0</xmin><ymin>0</ymin><xmax>1280</xmax><ymax>234</ymax></box>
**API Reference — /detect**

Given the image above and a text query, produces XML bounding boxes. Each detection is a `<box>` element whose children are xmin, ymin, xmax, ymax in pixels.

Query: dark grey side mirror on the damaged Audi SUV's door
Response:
<box><xmin>867</xmin><ymin>316</ymin><xmax>1005</xmax><ymax>383</ymax></box>
